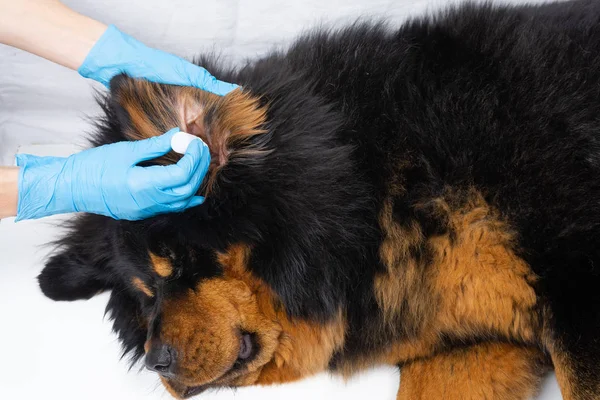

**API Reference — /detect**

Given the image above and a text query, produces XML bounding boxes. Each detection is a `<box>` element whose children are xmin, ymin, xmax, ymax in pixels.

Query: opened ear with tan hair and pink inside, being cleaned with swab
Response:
<box><xmin>110</xmin><ymin>75</ymin><xmax>266</xmax><ymax>194</ymax></box>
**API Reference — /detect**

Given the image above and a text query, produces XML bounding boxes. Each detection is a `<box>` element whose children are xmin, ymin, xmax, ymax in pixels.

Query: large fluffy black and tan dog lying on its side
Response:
<box><xmin>40</xmin><ymin>0</ymin><xmax>600</xmax><ymax>399</ymax></box>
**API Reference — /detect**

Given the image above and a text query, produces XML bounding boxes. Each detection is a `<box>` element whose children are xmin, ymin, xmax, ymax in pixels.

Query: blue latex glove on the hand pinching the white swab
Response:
<box><xmin>17</xmin><ymin>128</ymin><xmax>210</xmax><ymax>221</ymax></box>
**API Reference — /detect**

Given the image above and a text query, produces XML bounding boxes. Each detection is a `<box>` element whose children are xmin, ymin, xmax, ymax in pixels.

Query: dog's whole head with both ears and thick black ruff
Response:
<box><xmin>39</xmin><ymin>76</ymin><xmax>365</xmax><ymax>397</ymax></box>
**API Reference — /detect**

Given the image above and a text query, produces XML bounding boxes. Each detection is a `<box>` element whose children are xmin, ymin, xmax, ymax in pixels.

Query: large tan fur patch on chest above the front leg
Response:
<box><xmin>370</xmin><ymin>188</ymin><xmax>541</xmax><ymax>380</ymax></box>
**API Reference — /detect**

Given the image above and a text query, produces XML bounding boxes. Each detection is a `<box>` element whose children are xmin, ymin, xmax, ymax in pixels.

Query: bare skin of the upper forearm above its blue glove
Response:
<box><xmin>0</xmin><ymin>0</ymin><xmax>107</xmax><ymax>69</ymax></box>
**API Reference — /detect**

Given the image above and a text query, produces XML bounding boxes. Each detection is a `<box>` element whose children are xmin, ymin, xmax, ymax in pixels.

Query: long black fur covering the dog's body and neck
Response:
<box><xmin>40</xmin><ymin>0</ymin><xmax>600</xmax><ymax>394</ymax></box>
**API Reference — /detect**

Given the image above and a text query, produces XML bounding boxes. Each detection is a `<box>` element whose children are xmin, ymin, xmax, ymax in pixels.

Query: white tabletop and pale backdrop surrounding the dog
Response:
<box><xmin>0</xmin><ymin>0</ymin><xmax>561</xmax><ymax>400</ymax></box>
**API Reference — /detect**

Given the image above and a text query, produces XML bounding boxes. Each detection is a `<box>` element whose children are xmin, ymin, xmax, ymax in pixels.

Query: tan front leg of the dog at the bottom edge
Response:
<box><xmin>397</xmin><ymin>343</ymin><xmax>548</xmax><ymax>400</ymax></box>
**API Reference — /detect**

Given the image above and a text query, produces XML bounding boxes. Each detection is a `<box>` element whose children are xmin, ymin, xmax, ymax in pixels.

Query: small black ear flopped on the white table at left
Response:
<box><xmin>38</xmin><ymin>215</ymin><xmax>122</xmax><ymax>301</ymax></box>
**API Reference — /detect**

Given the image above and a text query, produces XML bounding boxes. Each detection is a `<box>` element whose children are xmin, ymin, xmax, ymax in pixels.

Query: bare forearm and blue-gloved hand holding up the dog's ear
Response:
<box><xmin>0</xmin><ymin>0</ymin><xmax>237</xmax><ymax>95</ymax></box>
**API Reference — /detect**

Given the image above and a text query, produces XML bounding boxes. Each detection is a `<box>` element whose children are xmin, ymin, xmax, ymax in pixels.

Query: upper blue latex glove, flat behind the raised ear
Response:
<box><xmin>78</xmin><ymin>25</ymin><xmax>238</xmax><ymax>96</ymax></box>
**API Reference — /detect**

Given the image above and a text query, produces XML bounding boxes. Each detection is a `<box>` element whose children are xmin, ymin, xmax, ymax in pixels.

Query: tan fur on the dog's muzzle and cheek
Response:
<box><xmin>160</xmin><ymin>245</ymin><xmax>345</xmax><ymax>394</ymax></box>
